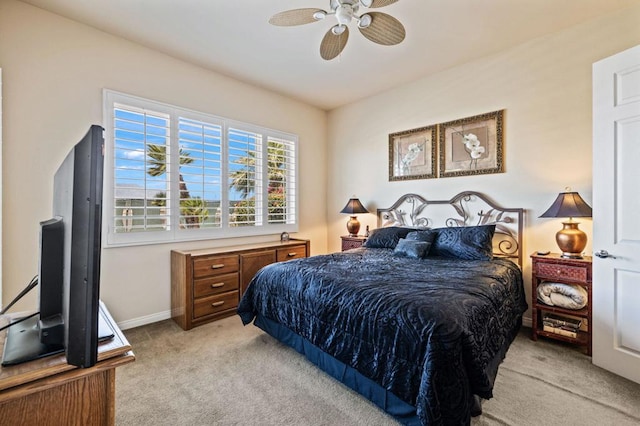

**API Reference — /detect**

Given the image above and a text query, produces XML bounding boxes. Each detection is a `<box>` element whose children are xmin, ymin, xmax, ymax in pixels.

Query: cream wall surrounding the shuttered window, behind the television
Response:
<box><xmin>0</xmin><ymin>0</ymin><xmax>327</xmax><ymax>326</ymax></box>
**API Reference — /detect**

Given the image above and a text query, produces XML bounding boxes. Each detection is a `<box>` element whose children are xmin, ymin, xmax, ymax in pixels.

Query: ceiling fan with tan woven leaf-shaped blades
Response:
<box><xmin>269</xmin><ymin>0</ymin><xmax>405</xmax><ymax>60</ymax></box>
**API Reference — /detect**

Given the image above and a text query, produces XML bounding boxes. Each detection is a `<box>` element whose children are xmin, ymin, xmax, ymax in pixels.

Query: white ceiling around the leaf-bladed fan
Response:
<box><xmin>17</xmin><ymin>0</ymin><xmax>638</xmax><ymax>109</ymax></box>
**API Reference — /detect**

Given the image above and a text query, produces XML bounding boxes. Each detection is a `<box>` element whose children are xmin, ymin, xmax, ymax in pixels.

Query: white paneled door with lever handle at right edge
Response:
<box><xmin>592</xmin><ymin>46</ymin><xmax>640</xmax><ymax>383</ymax></box>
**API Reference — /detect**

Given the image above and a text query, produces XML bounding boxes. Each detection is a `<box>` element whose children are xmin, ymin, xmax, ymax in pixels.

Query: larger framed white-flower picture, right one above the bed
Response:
<box><xmin>438</xmin><ymin>110</ymin><xmax>504</xmax><ymax>177</ymax></box>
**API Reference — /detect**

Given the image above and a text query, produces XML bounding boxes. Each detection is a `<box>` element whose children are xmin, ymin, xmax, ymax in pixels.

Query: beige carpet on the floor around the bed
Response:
<box><xmin>116</xmin><ymin>317</ymin><xmax>640</xmax><ymax>426</ymax></box>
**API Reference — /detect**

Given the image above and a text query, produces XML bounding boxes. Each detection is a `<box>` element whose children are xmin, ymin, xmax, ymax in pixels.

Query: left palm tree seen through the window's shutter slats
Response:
<box><xmin>147</xmin><ymin>144</ymin><xmax>209</xmax><ymax>228</ymax></box>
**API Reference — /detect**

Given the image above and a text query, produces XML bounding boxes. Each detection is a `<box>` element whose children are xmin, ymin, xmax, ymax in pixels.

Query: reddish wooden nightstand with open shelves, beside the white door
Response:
<box><xmin>531</xmin><ymin>253</ymin><xmax>593</xmax><ymax>356</ymax></box>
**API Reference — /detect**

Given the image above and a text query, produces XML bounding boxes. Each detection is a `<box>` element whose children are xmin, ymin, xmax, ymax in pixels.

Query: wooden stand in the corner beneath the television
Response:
<box><xmin>0</xmin><ymin>304</ymin><xmax>135</xmax><ymax>426</ymax></box>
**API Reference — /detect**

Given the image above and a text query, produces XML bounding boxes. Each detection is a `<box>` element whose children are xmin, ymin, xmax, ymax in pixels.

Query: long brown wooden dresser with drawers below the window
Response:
<box><xmin>171</xmin><ymin>239</ymin><xmax>310</xmax><ymax>330</ymax></box>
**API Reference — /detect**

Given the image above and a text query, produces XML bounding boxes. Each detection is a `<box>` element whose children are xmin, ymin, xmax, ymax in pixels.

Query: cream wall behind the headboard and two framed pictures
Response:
<box><xmin>327</xmin><ymin>6</ymin><xmax>640</xmax><ymax>322</ymax></box>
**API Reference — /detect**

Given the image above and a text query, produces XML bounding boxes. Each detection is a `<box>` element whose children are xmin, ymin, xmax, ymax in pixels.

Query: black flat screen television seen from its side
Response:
<box><xmin>2</xmin><ymin>125</ymin><xmax>112</xmax><ymax>367</ymax></box>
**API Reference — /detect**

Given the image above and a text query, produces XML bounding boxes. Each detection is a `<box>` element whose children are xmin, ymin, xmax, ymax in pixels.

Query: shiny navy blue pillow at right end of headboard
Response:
<box><xmin>429</xmin><ymin>225</ymin><xmax>496</xmax><ymax>260</ymax></box>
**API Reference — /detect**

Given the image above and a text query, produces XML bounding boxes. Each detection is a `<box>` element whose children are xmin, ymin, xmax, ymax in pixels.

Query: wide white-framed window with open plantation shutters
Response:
<box><xmin>103</xmin><ymin>90</ymin><xmax>297</xmax><ymax>245</ymax></box>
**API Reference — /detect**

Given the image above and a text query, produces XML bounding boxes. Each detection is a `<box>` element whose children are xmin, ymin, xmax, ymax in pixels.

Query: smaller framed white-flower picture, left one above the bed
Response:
<box><xmin>389</xmin><ymin>125</ymin><xmax>437</xmax><ymax>181</ymax></box>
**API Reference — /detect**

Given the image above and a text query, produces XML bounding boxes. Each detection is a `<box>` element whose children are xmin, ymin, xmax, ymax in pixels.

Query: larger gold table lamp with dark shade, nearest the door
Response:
<box><xmin>540</xmin><ymin>188</ymin><xmax>591</xmax><ymax>259</ymax></box>
